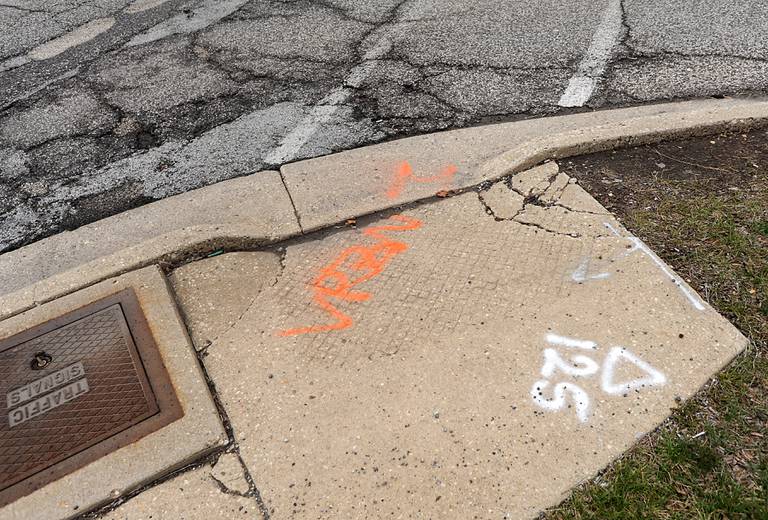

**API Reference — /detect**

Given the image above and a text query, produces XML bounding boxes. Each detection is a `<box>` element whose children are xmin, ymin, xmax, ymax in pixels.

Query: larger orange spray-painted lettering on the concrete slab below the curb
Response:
<box><xmin>279</xmin><ymin>215</ymin><xmax>422</xmax><ymax>336</ymax></box>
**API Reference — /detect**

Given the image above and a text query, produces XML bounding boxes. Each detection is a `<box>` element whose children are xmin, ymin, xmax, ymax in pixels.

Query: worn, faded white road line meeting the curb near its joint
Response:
<box><xmin>264</xmin><ymin>38</ymin><xmax>392</xmax><ymax>164</ymax></box>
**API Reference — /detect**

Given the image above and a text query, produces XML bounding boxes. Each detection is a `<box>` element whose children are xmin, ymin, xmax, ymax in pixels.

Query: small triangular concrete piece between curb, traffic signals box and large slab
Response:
<box><xmin>170</xmin><ymin>251</ymin><xmax>282</xmax><ymax>350</ymax></box>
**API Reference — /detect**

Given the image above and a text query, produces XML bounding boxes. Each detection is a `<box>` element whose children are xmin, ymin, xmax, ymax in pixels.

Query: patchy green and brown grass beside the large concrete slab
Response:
<box><xmin>543</xmin><ymin>172</ymin><xmax>768</xmax><ymax>520</ymax></box>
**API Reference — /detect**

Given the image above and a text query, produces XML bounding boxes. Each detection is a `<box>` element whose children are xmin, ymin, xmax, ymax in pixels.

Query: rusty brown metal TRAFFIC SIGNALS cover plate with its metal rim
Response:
<box><xmin>0</xmin><ymin>290</ymin><xmax>182</xmax><ymax>507</ymax></box>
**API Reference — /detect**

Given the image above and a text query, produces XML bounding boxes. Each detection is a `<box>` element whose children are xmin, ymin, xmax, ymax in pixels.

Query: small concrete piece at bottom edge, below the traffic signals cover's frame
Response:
<box><xmin>101</xmin><ymin>465</ymin><xmax>262</xmax><ymax>520</ymax></box>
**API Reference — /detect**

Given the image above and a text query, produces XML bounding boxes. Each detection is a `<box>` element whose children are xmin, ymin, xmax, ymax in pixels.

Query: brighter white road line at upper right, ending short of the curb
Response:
<box><xmin>558</xmin><ymin>0</ymin><xmax>622</xmax><ymax>107</ymax></box>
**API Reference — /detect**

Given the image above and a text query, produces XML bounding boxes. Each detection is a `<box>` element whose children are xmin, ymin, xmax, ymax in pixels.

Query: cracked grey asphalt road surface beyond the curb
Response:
<box><xmin>0</xmin><ymin>0</ymin><xmax>768</xmax><ymax>252</ymax></box>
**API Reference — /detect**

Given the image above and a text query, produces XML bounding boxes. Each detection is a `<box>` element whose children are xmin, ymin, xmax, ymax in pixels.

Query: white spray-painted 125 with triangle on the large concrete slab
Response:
<box><xmin>531</xmin><ymin>333</ymin><xmax>667</xmax><ymax>422</ymax></box>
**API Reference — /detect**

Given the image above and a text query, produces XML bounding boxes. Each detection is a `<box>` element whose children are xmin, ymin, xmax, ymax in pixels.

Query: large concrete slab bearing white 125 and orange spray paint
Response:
<box><xmin>176</xmin><ymin>173</ymin><xmax>747</xmax><ymax>519</ymax></box>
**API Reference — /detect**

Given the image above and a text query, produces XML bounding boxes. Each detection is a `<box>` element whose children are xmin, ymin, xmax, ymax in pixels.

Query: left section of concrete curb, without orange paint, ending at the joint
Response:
<box><xmin>0</xmin><ymin>171</ymin><xmax>300</xmax><ymax>319</ymax></box>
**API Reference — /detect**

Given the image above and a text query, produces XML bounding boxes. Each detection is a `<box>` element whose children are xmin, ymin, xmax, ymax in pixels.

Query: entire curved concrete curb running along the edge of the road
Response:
<box><xmin>0</xmin><ymin>98</ymin><xmax>768</xmax><ymax>319</ymax></box>
